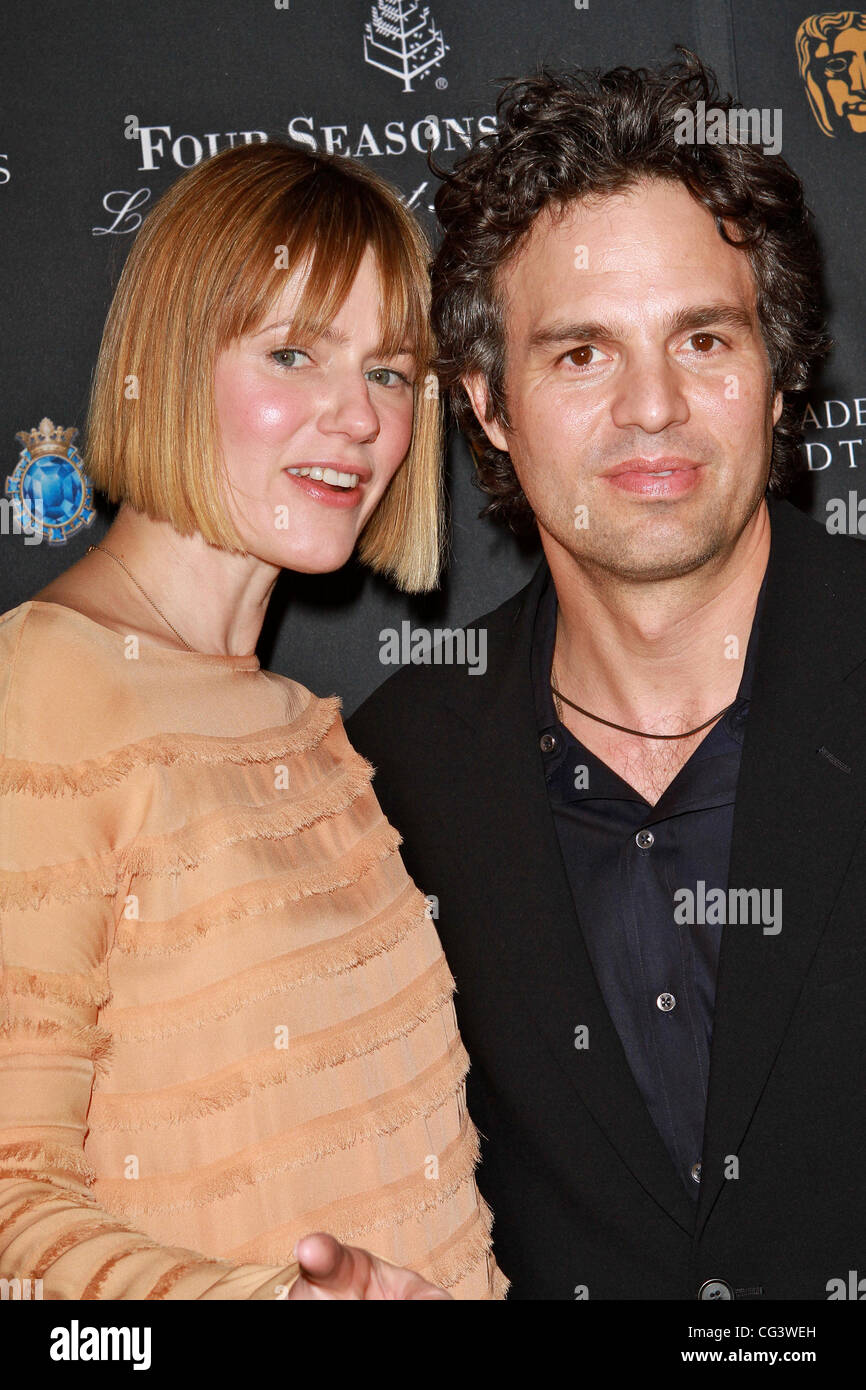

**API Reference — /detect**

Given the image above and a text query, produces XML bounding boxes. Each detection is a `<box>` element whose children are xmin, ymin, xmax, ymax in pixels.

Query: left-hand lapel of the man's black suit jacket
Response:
<box><xmin>453</xmin><ymin>562</ymin><xmax>695</xmax><ymax>1232</ymax></box>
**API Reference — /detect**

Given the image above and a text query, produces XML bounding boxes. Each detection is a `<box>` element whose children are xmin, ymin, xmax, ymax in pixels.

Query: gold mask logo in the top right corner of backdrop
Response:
<box><xmin>796</xmin><ymin>10</ymin><xmax>866</xmax><ymax>139</ymax></box>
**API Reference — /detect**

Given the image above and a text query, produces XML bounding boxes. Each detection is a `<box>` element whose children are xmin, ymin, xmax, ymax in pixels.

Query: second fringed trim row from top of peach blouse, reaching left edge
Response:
<box><xmin>0</xmin><ymin>752</ymin><xmax>371</xmax><ymax>910</ymax></box>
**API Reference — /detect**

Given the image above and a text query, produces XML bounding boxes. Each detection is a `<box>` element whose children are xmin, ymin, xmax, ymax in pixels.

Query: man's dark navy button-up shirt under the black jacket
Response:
<box><xmin>531</xmin><ymin>561</ymin><xmax>766</xmax><ymax>1198</ymax></box>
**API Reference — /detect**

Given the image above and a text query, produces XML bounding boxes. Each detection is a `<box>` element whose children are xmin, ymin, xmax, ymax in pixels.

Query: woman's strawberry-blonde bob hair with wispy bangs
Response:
<box><xmin>86</xmin><ymin>142</ymin><xmax>443</xmax><ymax>592</ymax></box>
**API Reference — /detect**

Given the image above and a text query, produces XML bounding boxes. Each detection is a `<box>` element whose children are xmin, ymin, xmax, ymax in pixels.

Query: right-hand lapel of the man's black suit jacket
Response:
<box><xmin>698</xmin><ymin>503</ymin><xmax>866</xmax><ymax>1229</ymax></box>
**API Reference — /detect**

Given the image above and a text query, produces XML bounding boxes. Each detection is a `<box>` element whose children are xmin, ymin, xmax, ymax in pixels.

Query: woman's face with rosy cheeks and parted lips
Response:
<box><xmin>214</xmin><ymin>249</ymin><xmax>416</xmax><ymax>574</ymax></box>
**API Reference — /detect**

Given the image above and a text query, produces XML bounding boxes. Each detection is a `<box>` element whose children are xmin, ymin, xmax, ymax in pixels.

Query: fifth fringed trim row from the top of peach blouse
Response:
<box><xmin>88</xmin><ymin>955</ymin><xmax>455</xmax><ymax>1131</ymax></box>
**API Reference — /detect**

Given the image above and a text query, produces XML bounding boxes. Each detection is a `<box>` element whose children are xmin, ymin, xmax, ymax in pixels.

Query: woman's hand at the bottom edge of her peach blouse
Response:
<box><xmin>289</xmin><ymin>1232</ymin><xmax>452</xmax><ymax>1301</ymax></box>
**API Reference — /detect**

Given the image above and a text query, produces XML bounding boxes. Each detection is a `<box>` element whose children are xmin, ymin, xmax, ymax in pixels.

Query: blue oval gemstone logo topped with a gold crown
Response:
<box><xmin>6</xmin><ymin>418</ymin><xmax>96</xmax><ymax>545</ymax></box>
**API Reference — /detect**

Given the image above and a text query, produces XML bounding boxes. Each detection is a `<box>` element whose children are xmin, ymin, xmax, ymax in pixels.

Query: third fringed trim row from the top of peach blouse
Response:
<box><xmin>114</xmin><ymin>817</ymin><xmax>400</xmax><ymax>956</ymax></box>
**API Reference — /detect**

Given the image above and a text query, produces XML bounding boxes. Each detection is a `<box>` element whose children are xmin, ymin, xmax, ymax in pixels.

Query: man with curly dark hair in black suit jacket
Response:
<box><xmin>349</xmin><ymin>54</ymin><xmax>866</xmax><ymax>1300</ymax></box>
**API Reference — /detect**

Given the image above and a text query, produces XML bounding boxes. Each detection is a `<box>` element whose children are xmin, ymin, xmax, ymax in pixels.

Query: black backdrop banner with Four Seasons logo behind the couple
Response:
<box><xmin>0</xmin><ymin>0</ymin><xmax>866</xmax><ymax>714</ymax></box>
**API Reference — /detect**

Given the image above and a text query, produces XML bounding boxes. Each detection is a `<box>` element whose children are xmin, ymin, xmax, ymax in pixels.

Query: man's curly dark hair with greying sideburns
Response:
<box><xmin>432</xmin><ymin>46</ymin><xmax>831</xmax><ymax>531</ymax></box>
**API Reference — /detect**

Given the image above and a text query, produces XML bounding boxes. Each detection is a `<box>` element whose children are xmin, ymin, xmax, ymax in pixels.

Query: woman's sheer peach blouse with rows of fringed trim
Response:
<box><xmin>0</xmin><ymin>602</ymin><xmax>507</xmax><ymax>1298</ymax></box>
